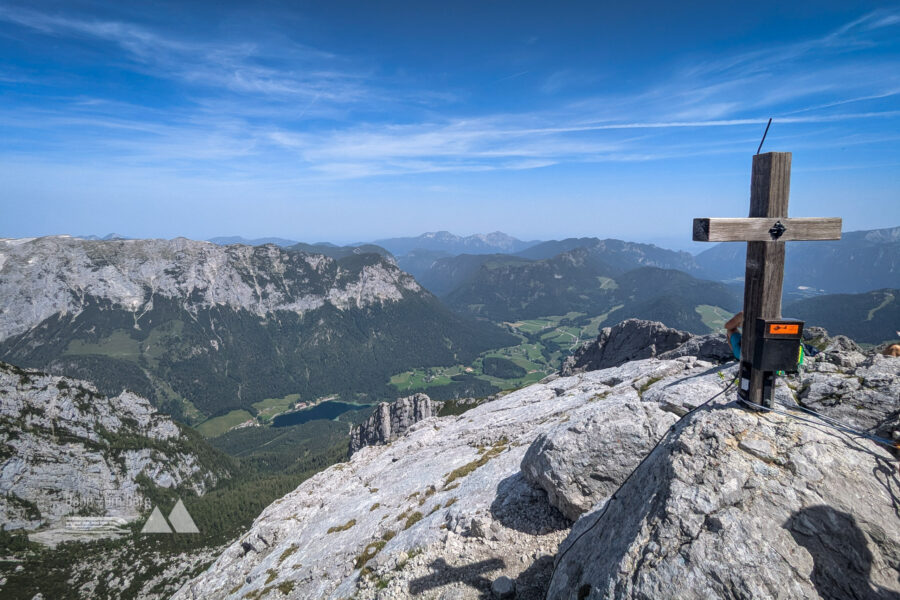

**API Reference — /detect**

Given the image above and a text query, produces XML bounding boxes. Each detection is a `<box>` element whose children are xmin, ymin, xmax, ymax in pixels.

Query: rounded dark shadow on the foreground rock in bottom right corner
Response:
<box><xmin>783</xmin><ymin>506</ymin><xmax>900</xmax><ymax>600</ymax></box>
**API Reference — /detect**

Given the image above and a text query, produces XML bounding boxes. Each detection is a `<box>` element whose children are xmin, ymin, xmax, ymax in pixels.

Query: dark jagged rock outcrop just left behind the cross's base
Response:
<box><xmin>561</xmin><ymin>319</ymin><xmax>734</xmax><ymax>376</ymax></box>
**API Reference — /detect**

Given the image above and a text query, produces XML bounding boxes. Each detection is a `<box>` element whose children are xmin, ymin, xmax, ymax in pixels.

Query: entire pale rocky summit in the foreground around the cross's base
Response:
<box><xmin>175</xmin><ymin>322</ymin><xmax>900</xmax><ymax>599</ymax></box>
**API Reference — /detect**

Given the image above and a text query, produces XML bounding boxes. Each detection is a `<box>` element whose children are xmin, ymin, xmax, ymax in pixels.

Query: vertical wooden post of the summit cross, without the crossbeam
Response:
<box><xmin>740</xmin><ymin>152</ymin><xmax>791</xmax><ymax>407</ymax></box>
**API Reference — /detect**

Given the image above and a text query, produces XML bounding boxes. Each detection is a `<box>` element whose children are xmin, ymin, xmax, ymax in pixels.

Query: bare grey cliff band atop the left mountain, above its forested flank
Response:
<box><xmin>0</xmin><ymin>236</ymin><xmax>421</xmax><ymax>340</ymax></box>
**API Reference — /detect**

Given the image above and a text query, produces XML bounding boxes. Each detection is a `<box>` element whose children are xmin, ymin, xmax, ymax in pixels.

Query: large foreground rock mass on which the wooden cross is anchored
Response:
<box><xmin>548</xmin><ymin>384</ymin><xmax>900</xmax><ymax>599</ymax></box>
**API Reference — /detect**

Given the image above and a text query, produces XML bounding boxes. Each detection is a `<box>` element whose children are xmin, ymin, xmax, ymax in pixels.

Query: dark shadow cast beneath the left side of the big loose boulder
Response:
<box><xmin>491</xmin><ymin>471</ymin><xmax>571</xmax><ymax>535</ymax></box>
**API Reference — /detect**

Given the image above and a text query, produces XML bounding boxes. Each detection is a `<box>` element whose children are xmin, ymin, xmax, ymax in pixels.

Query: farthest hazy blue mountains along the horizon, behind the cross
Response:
<box><xmin>207</xmin><ymin>227</ymin><xmax>900</xmax><ymax>302</ymax></box>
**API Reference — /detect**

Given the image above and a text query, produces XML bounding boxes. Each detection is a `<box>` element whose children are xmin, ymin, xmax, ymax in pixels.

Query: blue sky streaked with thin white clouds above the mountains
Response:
<box><xmin>0</xmin><ymin>0</ymin><xmax>900</xmax><ymax>247</ymax></box>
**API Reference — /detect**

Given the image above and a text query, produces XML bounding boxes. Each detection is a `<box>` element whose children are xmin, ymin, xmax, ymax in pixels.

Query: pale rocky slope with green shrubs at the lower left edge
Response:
<box><xmin>0</xmin><ymin>363</ymin><xmax>230</xmax><ymax>529</ymax></box>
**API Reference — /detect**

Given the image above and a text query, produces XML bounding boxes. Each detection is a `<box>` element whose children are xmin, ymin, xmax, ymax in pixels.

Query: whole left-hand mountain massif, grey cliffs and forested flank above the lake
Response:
<box><xmin>0</xmin><ymin>237</ymin><xmax>516</xmax><ymax>423</ymax></box>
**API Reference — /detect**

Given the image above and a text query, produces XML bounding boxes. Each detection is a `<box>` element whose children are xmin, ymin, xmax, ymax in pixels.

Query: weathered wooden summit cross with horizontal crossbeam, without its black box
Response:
<box><xmin>694</xmin><ymin>152</ymin><xmax>841</xmax><ymax>408</ymax></box>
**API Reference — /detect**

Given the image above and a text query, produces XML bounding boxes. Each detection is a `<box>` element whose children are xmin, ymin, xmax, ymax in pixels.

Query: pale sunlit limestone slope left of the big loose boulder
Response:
<box><xmin>175</xmin><ymin>359</ymin><xmax>715</xmax><ymax>600</ymax></box>
